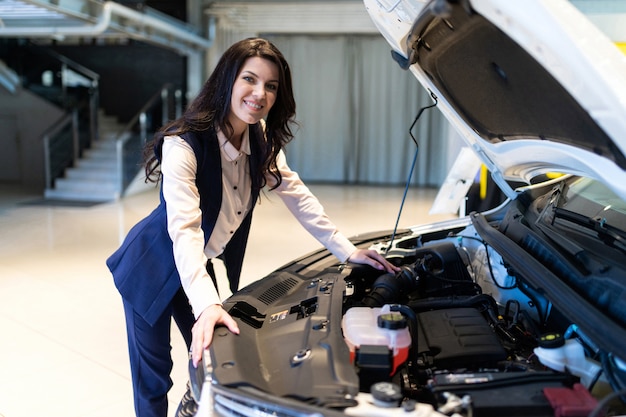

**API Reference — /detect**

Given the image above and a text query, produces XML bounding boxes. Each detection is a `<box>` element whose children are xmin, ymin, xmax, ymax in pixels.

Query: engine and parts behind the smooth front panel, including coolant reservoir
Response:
<box><xmin>342</xmin><ymin>236</ymin><xmax>601</xmax><ymax>417</ymax></box>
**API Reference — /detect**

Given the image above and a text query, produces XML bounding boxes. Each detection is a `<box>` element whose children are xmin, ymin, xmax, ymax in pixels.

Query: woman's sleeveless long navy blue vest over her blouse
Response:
<box><xmin>106</xmin><ymin>123</ymin><xmax>265</xmax><ymax>324</ymax></box>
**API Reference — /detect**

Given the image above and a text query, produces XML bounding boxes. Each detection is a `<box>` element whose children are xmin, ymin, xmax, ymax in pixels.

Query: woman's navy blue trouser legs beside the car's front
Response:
<box><xmin>124</xmin><ymin>287</ymin><xmax>195</xmax><ymax>417</ymax></box>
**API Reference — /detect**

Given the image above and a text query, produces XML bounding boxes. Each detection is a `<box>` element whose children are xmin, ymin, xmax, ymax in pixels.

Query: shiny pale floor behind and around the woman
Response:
<box><xmin>0</xmin><ymin>185</ymin><xmax>450</xmax><ymax>417</ymax></box>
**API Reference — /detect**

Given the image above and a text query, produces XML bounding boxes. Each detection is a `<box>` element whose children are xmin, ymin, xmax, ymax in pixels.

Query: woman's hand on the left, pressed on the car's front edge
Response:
<box><xmin>190</xmin><ymin>304</ymin><xmax>239</xmax><ymax>368</ymax></box>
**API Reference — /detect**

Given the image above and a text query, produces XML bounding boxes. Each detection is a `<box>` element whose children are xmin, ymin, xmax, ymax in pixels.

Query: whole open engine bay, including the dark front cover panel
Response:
<box><xmin>211</xmin><ymin>214</ymin><xmax>619</xmax><ymax>417</ymax></box>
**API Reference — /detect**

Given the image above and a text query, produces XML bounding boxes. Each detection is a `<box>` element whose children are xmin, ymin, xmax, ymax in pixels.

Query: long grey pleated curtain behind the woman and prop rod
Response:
<box><xmin>263</xmin><ymin>35</ymin><xmax>448</xmax><ymax>186</ymax></box>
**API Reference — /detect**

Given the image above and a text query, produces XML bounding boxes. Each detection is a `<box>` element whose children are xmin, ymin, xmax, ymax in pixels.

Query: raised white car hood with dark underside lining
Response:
<box><xmin>364</xmin><ymin>0</ymin><xmax>626</xmax><ymax>198</ymax></box>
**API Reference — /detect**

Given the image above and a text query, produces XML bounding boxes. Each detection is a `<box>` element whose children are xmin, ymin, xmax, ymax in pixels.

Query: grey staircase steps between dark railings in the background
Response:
<box><xmin>44</xmin><ymin>111</ymin><xmax>124</xmax><ymax>202</ymax></box>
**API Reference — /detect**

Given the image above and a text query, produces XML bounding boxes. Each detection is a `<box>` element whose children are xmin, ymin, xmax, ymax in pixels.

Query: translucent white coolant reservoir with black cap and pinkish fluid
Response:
<box><xmin>341</xmin><ymin>305</ymin><xmax>411</xmax><ymax>375</ymax></box>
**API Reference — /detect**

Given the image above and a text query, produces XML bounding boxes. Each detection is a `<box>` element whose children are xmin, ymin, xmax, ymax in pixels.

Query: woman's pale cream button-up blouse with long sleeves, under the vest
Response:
<box><xmin>161</xmin><ymin>125</ymin><xmax>356</xmax><ymax>318</ymax></box>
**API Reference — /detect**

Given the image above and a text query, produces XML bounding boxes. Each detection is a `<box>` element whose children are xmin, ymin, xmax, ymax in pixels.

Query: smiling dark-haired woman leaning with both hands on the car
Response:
<box><xmin>107</xmin><ymin>38</ymin><xmax>397</xmax><ymax>417</ymax></box>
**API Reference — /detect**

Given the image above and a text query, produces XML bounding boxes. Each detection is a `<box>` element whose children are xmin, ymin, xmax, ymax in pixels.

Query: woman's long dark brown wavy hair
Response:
<box><xmin>144</xmin><ymin>38</ymin><xmax>296</xmax><ymax>188</ymax></box>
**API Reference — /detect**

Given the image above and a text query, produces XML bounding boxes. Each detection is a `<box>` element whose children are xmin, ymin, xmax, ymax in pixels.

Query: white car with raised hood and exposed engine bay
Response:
<box><xmin>178</xmin><ymin>0</ymin><xmax>626</xmax><ymax>417</ymax></box>
